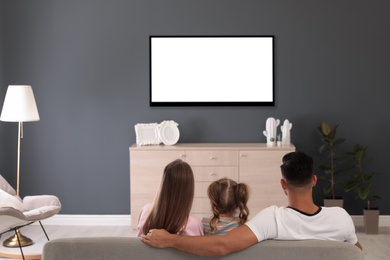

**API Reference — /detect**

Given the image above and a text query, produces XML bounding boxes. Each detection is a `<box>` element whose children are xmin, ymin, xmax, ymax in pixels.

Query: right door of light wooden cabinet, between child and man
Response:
<box><xmin>239</xmin><ymin>150</ymin><xmax>290</xmax><ymax>218</ymax></box>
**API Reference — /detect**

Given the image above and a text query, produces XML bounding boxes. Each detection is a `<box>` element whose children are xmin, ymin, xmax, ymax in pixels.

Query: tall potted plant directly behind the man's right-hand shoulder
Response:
<box><xmin>317</xmin><ymin>122</ymin><xmax>345</xmax><ymax>207</ymax></box>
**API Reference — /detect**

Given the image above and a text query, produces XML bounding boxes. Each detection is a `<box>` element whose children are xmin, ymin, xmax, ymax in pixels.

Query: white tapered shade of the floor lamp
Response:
<box><xmin>0</xmin><ymin>85</ymin><xmax>39</xmax><ymax>122</ymax></box>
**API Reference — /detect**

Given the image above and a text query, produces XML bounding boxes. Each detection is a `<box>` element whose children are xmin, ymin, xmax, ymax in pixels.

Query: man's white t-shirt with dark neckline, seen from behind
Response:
<box><xmin>246</xmin><ymin>206</ymin><xmax>358</xmax><ymax>244</ymax></box>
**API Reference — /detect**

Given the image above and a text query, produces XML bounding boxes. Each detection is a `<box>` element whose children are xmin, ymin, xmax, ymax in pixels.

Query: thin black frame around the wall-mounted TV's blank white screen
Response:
<box><xmin>149</xmin><ymin>35</ymin><xmax>275</xmax><ymax>107</ymax></box>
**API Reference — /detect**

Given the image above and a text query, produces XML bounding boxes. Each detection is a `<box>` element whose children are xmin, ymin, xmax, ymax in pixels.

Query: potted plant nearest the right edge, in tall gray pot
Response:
<box><xmin>345</xmin><ymin>144</ymin><xmax>380</xmax><ymax>234</ymax></box>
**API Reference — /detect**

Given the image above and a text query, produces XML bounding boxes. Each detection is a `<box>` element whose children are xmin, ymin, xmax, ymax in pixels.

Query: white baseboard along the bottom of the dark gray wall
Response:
<box><xmin>34</xmin><ymin>214</ymin><xmax>390</xmax><ymax>227</ymax></box>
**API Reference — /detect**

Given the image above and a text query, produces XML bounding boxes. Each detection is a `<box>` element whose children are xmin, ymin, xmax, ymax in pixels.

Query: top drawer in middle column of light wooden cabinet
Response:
<box><xmin>186</xmin><ymin>150</ymin><xmax>238</xmax><ymax>166</ymax></box>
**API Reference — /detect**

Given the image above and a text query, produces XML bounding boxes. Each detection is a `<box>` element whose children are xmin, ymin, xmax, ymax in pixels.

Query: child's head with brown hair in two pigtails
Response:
<box><xmin>207</xmin><ymin>178</ymin><xmax>249</xmax><ymax>230</ymax></box>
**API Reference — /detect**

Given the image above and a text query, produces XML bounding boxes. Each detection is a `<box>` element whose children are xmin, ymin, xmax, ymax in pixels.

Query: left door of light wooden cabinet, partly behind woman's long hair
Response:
<box><xmin>130</xmin><ymin>151</ymin><xmax>185</xmax><ymax>228</ymax></box>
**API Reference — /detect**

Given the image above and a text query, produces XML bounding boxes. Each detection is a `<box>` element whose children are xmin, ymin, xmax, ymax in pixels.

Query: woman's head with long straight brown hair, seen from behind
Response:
<box><xmin>143</xmin><ymin>159</ymin><xmax>195</xmax><ymax>234</ymax></box>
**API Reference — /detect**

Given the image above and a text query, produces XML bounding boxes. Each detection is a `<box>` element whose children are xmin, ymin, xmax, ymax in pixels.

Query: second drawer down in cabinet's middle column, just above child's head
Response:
<box><xmin>192</xmin><ymin>166</ymin><xmax>238</xmax><ymax>182</ymax></box>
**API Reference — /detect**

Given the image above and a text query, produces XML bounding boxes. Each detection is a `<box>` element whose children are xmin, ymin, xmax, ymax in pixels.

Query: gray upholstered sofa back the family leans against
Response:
<box><xmin>42</xmin><ymin>237</ymin><xmax>364</xmax><ymax>260</ymax></box>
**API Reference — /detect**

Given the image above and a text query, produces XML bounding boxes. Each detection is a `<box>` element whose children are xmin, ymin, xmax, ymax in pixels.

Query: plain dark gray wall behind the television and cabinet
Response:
<box><xmin>0</xmin><ymin>0</ymin><xmax>390</xmax><ymax>215</ymax></box>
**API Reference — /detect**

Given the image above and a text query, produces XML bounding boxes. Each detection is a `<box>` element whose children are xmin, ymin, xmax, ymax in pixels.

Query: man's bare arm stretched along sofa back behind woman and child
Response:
<box><xmin>141</xmin><ymin>225</ymin><xmax>258</xmax><ymax>256</ymax></box>
